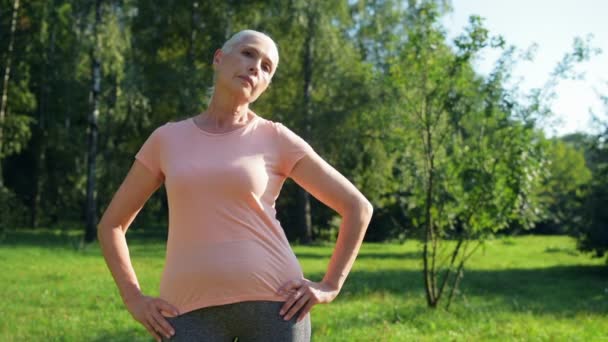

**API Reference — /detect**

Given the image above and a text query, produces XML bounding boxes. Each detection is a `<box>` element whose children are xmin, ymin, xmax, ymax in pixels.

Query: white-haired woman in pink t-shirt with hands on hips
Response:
<box><xmin>98</xmin><ymin>30</ymin><xmax>372</xmax><ymax>341</ymax></box>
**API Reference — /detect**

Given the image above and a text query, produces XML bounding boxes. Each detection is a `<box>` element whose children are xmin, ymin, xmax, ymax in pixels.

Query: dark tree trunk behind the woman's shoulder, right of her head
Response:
<box><xmin>297</xmin><ymin>10</ymin><xmax>316</xmax><ymax>244</ymax></box>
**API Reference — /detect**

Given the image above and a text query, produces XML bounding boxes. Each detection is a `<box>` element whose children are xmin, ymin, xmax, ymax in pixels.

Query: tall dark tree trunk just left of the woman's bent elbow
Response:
<box><xmin>84</xmin><ymin>0</ymin><xmax>102</xmax><ymax>243</ymax></box>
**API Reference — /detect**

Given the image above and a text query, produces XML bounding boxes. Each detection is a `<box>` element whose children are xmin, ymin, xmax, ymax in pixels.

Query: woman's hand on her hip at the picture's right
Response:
<box><xmin>277</xmin><ymin>279</ymin><xmax>340</xmax><ymax>322</ymax></box>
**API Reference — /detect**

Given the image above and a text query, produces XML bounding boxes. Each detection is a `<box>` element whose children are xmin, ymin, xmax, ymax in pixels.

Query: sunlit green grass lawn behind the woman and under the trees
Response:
<box><xmin>0</xmin><ymin>231</ymin><xmax>608</xmax><ymax>341</ymax></box>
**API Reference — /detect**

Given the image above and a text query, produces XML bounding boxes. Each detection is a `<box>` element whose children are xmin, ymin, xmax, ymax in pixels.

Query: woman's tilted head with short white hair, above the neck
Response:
<box><xmin>213</xmin><ymin>34</ymin><xmax>279</xmax><ymax>103</ymax></box>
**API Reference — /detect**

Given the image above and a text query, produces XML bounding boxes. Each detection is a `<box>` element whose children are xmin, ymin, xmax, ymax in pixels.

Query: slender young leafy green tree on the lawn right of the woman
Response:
<box><xmin>390</xmin><ymin>1</ymin><xmax>542</xmax><ymax>308</ymax></box>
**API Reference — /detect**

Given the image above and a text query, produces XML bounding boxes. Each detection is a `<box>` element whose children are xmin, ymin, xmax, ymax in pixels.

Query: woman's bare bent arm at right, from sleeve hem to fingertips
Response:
<box><xmin>279</xmin><ymin>153</ymin><xmax>373</xmax><ymax>320</ymax></box>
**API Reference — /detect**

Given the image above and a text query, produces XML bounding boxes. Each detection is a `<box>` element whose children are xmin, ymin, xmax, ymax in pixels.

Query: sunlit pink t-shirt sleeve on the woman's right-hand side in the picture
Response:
<box><xmin>276</xmin><ymin>123</ymin><xmax>314</xmax><ymax>177</ymax></box>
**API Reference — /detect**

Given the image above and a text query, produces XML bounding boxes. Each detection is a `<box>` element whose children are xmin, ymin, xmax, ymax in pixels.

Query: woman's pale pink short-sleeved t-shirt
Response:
<box><xmin>135</xmin><ymin>116</ymin><xmax>314</xmax><ymax>313</ymax></box>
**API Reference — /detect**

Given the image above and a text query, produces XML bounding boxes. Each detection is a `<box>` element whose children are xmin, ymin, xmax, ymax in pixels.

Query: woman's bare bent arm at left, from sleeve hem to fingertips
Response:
<box><xmin>97</xmin><ymin>160</ymin><xmax>178</xmax><ymax>340</ymax></box>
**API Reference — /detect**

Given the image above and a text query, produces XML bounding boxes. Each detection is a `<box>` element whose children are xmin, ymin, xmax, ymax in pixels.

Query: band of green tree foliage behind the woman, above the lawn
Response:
<box><xmin>0</xmin><ymin>0</ymin><xmax>605</xmax><ymax>264</ymax></box>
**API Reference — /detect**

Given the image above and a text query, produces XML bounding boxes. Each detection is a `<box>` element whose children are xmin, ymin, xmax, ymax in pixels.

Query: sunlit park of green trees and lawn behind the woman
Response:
<box><xmin>0</xmin><ymin>0</ymin><xmax>608</xmax><ymax>341</ymax></box>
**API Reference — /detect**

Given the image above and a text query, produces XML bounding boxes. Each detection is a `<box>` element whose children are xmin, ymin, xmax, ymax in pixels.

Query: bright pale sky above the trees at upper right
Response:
<box><xmin>444</xmin><ymin>0</ymin><xmax>608</xmax><ymax>136</ymax></box>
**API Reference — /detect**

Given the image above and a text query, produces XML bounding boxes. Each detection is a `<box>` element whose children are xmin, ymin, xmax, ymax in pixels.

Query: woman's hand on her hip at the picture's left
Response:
<box><xmin>126</xmin><ymin>294</ymin><xmax>179</xmax><ymax>341</ymax></box>
